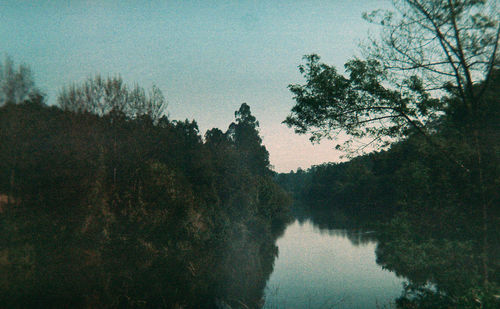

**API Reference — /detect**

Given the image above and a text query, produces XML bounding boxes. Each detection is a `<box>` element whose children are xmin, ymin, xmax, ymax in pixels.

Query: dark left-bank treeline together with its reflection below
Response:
<box><xmin>0</xmin><ymin>64</ymin><xmax>289</xmax><ymax>308</ymax></box>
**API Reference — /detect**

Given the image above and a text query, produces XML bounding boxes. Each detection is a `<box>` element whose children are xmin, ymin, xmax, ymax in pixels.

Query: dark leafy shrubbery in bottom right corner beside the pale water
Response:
<box><xmin>376</xmin><ymin>216</ymin><xmax>500</xmax><ymax>308</ymax></box>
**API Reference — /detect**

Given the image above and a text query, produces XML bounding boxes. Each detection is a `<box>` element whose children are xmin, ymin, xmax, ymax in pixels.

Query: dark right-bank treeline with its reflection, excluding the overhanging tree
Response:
<box><xmin>277</xmin><ymin>71</ymin><xmax>500</xmax><ymax>308</ymax></box>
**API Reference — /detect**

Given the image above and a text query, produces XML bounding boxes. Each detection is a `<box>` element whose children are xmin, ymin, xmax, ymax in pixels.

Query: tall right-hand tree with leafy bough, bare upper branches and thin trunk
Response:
<box><xmin>284</xmin><ymin>0</ymin><xmax>500</xmax><ymax>286</ymax></box>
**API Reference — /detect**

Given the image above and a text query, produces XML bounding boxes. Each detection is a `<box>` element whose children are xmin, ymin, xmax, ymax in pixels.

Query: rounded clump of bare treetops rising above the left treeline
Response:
<box><xmin>57</xmin><ymin>75</ymin><xmax>167</xmax><ymax>122</ymax></box>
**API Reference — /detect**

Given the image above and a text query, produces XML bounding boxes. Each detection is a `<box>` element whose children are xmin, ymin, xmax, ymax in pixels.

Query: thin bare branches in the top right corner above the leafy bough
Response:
<box><xmin>364</xmin><ymin>0</ymin><xmax>500</xmax><ymax>115</ymax></box>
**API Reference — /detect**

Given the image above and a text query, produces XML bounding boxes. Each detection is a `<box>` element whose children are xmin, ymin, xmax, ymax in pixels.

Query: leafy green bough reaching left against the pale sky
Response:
<box><xmin>284</xmin><ymin>55</ymin><xmax>442</xmax><ymax>150</ymax></box>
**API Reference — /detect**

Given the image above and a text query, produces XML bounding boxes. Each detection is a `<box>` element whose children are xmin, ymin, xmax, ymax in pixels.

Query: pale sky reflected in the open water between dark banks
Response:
<box><xmin>265</xmin><ymin>221</ymin><xmax>403</xmax><ymax>308</ymax></box>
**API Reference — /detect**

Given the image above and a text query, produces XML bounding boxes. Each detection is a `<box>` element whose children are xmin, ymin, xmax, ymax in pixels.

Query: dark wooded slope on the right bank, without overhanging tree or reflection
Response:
<box><xmin>276</xmin><ymin>72</ymin><xmax>500</xmax><ymax>233</ymax></box>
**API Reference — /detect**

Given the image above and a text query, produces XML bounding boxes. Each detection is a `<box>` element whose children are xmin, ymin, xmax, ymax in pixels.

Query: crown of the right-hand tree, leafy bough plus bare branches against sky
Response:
<box><xmin>285</xmin><ymin>0</ymin><xmax>500</xmax><ymax>153</ymax></box>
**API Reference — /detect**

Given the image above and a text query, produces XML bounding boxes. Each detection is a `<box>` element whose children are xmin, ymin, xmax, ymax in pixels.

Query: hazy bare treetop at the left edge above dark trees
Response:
<box><xmin>0</xmin><ymin>57</ymin><xmax>43</xmax><ymax>106</ymax></box>
